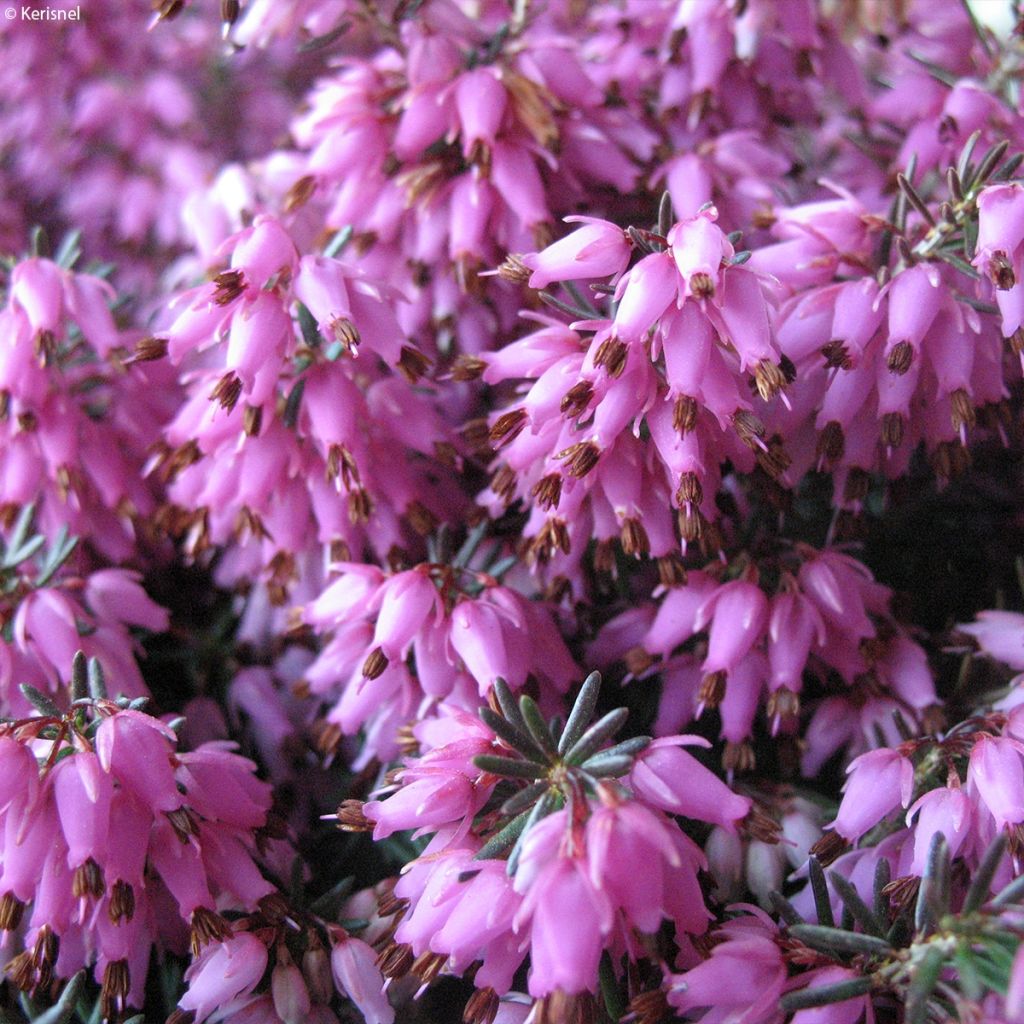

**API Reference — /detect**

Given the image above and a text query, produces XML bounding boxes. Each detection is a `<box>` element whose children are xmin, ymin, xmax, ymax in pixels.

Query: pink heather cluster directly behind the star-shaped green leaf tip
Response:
<box><xmin>303</xmin><ymin>552</ymin><xmax>577</xmax><ymax>761</ymax></box>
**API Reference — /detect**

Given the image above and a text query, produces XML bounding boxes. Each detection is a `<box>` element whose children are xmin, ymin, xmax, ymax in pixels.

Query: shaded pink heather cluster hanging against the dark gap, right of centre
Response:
<box><xmin>591</xmin><ymin>544</ymin><xmax>937</xmax><ymax>775</ymax></box>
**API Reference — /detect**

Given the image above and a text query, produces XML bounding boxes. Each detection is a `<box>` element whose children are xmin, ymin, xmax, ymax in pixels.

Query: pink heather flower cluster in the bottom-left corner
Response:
<box><xmin>0</xmin><ymin>684</ymin><xmax>272</xmax><ymax>1016</ymax></box>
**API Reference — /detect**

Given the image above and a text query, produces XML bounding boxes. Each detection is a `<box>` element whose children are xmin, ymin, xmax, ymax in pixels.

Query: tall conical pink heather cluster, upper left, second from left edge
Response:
<box><xmin>151</xmin><ymin>216</ymin><xmax>460</xmax><ymax>589</ymax></box>
